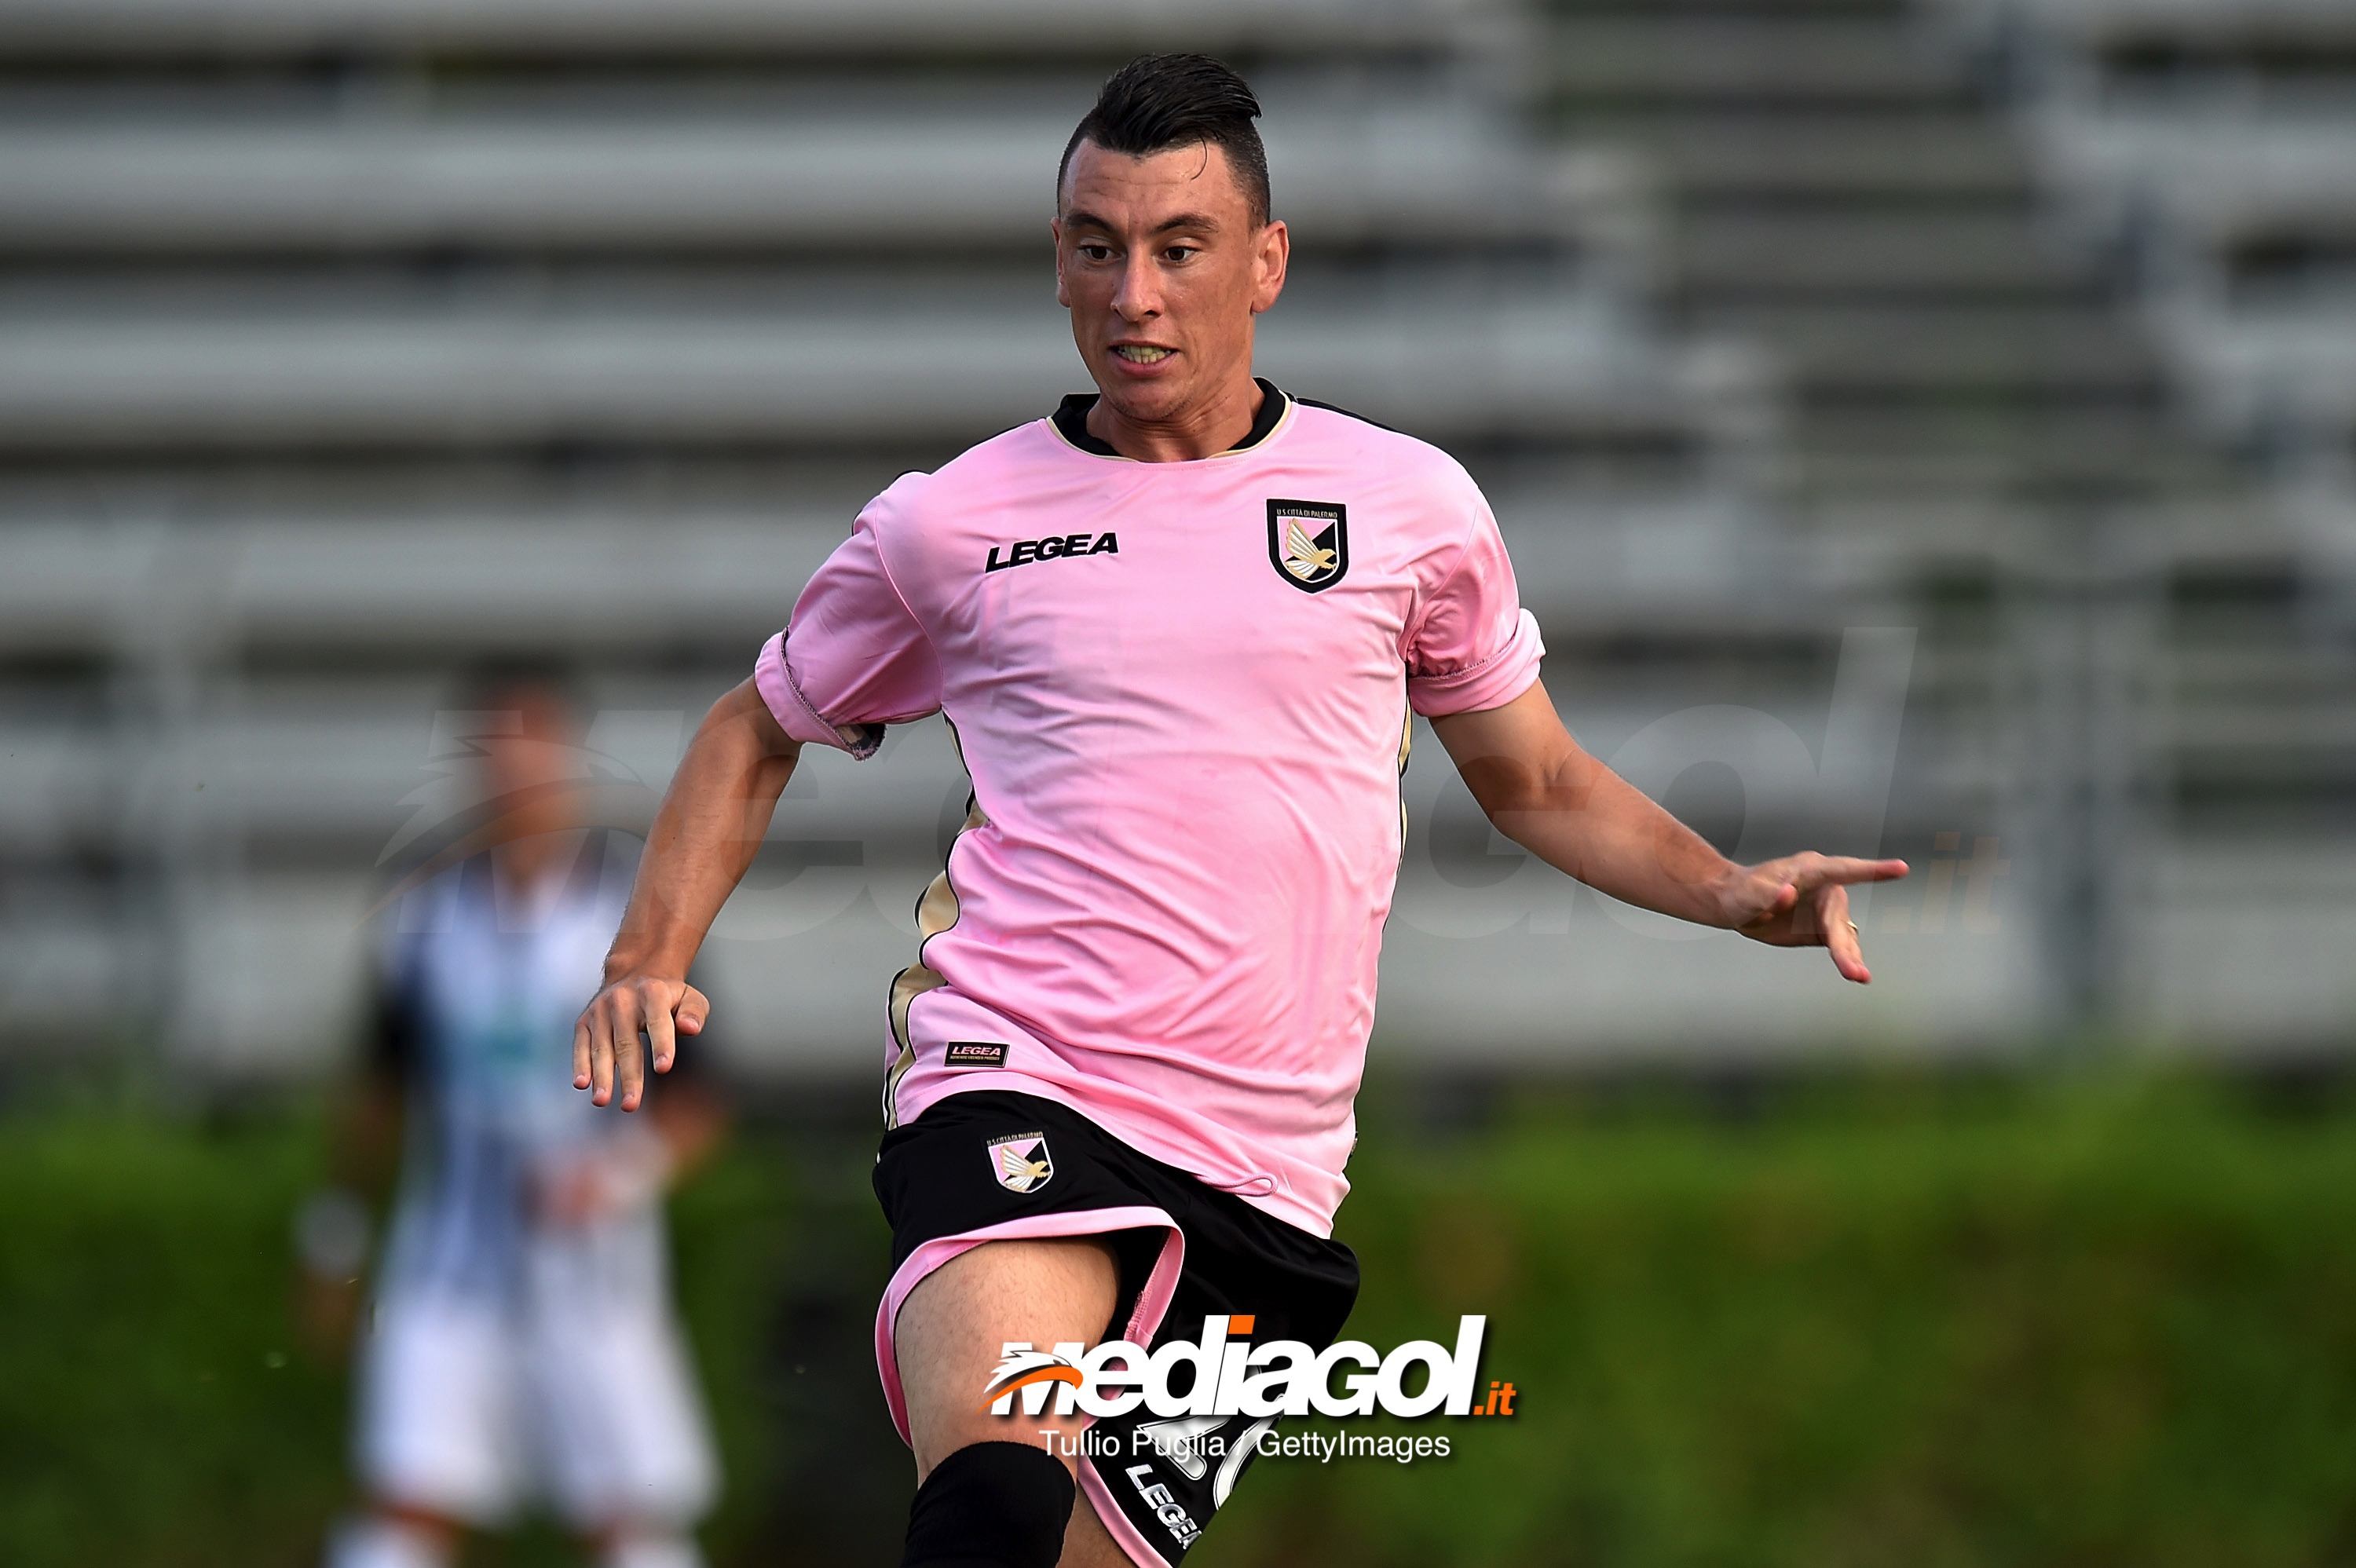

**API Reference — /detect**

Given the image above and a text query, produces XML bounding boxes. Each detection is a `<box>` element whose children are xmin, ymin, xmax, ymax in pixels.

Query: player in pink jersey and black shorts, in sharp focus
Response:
<box><xmin>575</xmin><ymin>57</ymin><xmax>1904</xmax><ymax>1568</ymax></box>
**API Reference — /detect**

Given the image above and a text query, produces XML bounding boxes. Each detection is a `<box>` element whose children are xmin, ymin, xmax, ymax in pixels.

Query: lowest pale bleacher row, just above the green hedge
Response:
<box><xmin>50</xmin><ymin>828</ymin><xmax>2356</xmax><ymax>1078</ymax></box>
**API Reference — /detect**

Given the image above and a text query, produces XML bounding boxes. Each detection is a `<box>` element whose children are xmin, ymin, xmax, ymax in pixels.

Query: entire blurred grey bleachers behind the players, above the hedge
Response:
<box><xmin>0</xmin><ymin>0</ymin><xmax>2356</xmax><ymax>1073</ymax></box>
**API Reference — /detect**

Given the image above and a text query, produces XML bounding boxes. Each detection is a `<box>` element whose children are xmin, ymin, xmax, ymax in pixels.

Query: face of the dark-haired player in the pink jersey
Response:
<box><xmin>1055</xmin><ymin>141</ymin><xmax>1286</xmax><ymax>424</ymax></box>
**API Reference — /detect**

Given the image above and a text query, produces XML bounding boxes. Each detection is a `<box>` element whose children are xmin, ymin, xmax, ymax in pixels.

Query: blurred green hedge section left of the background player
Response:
<box><xmin>0</xmin><ymin>1116</ymin><xmax>342</xmax><ymax>1568</ymax></box>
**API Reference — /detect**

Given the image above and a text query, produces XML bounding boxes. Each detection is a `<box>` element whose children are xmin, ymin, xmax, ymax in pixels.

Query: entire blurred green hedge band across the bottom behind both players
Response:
<box><xmin>0</xmin><ymin>1078</ymin><xmax>2356</xmax><ymax>1568</ymax></box>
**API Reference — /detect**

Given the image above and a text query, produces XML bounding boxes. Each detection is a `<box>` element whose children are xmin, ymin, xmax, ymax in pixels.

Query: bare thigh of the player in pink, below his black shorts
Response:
<box><xmin>893</xmin><ymin>1236</ymin><xmax>1119</xmax><ymax>1481</ymax></box>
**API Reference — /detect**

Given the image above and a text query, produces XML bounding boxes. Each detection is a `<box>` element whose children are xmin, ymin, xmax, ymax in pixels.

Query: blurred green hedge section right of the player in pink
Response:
<box><xmin>1216</xmin><ymin>1085</ymin><xmax>2356</xmax><ymax>1568</ymax></box>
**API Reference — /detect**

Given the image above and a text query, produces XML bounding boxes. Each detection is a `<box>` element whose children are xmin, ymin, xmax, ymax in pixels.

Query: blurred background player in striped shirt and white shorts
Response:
<box><xmin>299</xmin><ymin>667</ymin><xmax>721</xmax><ymax>1568</ymax></box>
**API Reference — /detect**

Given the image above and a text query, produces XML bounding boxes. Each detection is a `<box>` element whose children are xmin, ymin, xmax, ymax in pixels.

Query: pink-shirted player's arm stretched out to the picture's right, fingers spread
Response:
<box><xmin>1432</xmin><ymin>683</ymin><xmax>1906</xmax><ymax>984</ymax></box>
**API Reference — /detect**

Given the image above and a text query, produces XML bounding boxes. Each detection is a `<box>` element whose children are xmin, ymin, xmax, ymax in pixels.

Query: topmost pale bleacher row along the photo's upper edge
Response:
<box><xmin>0</xmin><ymin>0</ymin><xmax>1501</xmax><ymax>59</ymax></box>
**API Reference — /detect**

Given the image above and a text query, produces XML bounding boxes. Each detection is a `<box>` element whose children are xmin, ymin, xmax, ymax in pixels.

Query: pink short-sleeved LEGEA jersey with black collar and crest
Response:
<box><xmin>754</xmin><ymin>382</ymin><xmax>1543</xmax><ymax>1236</ymax></box>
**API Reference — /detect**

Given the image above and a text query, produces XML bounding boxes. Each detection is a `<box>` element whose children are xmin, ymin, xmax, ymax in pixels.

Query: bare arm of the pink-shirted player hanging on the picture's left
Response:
<box><xmin>573</xmin><ymin>681</ymin><xmax>801</xmax><ymax>1111</ymax></box>
